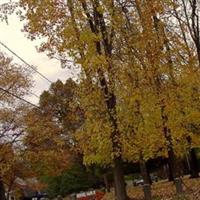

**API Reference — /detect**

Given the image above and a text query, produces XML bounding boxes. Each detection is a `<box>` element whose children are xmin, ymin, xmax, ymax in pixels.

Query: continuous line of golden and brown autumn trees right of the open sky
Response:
<box><xmin>0</xmin><ymin>0</ymin><xmax>200</xmax><ymax>200</ymax></box>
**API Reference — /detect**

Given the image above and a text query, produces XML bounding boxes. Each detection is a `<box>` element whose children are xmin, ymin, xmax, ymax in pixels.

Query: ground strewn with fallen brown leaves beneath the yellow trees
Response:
<box><xmin>103</xmin><ymin>176</ymin><xmax>200</xmax><ymax>200</ymax></box>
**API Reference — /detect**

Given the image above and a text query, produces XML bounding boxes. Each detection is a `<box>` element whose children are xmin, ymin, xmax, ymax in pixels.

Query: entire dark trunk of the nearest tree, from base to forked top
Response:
<box><xmin>81</xmin><ymin>1</ymin><xmax>128</xmax><ymax>200</ymax></box>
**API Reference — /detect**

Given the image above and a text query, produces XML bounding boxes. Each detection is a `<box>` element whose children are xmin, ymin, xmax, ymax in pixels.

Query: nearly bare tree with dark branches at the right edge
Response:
<box><xmin>166</xmin><ymin>0</ymin><xmax>200</xmax><ymax>177</ymax></box>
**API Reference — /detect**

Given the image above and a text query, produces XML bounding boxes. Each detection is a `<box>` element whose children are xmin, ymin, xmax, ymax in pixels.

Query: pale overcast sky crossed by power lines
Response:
<box><xmin>0</xmin><ymin>3</ymin><xmax>75</xmax><ymax>104</ymax></box>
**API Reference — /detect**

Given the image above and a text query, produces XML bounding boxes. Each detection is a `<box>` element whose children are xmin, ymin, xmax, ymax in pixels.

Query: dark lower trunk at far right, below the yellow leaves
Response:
<box><xmin>190</xmin><ymin>148</ymin><xmax>199</xmax><ymax>178</ymax></box>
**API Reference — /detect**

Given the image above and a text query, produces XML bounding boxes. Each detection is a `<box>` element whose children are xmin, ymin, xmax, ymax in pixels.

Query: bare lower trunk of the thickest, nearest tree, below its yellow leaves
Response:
<box><xmin>113</xmin><ymin>158</ymin><xmax>128</xmax><ymax>200</ymax></box>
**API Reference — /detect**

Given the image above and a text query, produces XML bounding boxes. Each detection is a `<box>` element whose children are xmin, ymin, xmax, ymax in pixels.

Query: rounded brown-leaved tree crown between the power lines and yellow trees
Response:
<box><xmin>39</xmin><ymin>79</ymin><xmax>84</xmax><ymax>147</ymax></box>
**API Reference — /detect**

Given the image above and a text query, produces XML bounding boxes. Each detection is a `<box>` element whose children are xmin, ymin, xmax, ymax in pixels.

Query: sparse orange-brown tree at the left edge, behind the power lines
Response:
<box><xmin>0</xmin><ymin>53</ymin><xmax>31</xmax><ymax>199</ymax></box>
